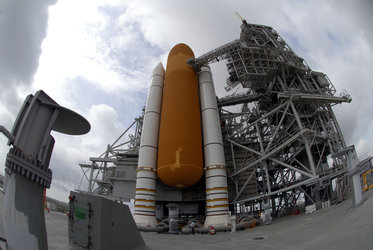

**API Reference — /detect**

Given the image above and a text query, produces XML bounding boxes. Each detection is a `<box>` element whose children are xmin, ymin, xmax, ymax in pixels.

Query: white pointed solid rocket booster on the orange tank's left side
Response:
<box><xmin>134</xmin><ymin>63</ymin><xmax>165</xmax><ymax>227</ymax></box>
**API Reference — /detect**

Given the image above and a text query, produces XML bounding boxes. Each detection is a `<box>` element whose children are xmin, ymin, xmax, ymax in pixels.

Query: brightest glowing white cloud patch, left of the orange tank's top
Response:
<box><xmin>33</xmin><ymin>1</ymin><xmax>156</xmax><ymax>112</ymax></box>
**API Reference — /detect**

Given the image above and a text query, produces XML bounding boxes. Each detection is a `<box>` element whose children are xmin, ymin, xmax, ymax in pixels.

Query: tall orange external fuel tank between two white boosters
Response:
<box><xmin>157</xmin><ymin>44</ymin><xmax>203</xmax><ymax>188</ymax></box>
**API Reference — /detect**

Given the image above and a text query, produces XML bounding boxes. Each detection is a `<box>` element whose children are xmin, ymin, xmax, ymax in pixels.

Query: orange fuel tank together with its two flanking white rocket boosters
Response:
<box><xmin>134</xmin><ymin>44</ymin><xmax>230</xmax><ymax>227</ymax></box>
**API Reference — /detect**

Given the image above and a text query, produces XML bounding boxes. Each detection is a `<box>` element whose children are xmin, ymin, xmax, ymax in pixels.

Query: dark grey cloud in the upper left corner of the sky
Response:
<box><xmin>0</xmin><ymin>0</ymin><xmax>55</xmax><ymax>176</ymax></box>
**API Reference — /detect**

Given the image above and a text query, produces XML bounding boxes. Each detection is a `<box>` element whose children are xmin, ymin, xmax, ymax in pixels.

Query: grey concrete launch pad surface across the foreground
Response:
<box><xmin>0</xmin><ymin>190</ymin><xmax>373</xmax><ymax>250</ymax></box>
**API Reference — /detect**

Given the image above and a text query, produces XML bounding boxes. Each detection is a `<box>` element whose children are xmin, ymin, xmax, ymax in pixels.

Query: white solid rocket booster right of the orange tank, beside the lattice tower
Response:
<box><xmin>198</xmin><ymin>67</ymin><xmax>230</xmax><ymax>227</ymax></box>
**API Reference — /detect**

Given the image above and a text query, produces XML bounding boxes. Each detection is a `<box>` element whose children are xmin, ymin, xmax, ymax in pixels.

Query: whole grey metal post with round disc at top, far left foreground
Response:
<box><xmin>3</xmin><ymin>90</ymin><xmax>90</xmax><ymax>250</ymax></box>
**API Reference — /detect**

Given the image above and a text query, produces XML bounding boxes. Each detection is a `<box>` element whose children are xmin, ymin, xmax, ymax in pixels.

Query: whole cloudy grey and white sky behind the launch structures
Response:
<box><xmin>0</xmin><ymin>0</ymin><xmax>373</xmax><ymax>201</ymax></box>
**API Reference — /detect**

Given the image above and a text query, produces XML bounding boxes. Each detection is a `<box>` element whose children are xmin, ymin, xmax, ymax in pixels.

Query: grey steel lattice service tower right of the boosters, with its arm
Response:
<box><xmin>189</xmin><ymin>21</ymin><xmax>351</xmax><ymax>214</ymax></box>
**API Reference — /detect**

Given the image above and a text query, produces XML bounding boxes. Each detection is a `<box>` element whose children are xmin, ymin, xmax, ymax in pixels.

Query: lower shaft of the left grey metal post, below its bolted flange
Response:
<box><xmin>2</xmin><ymin>168</ymin><xmax>48</xmax><ymax>249</ymax></box>
